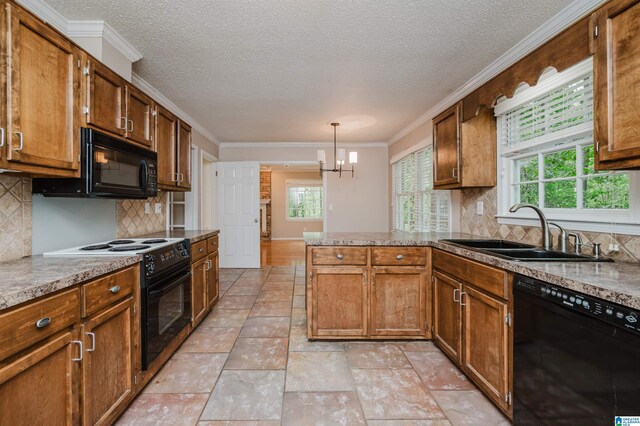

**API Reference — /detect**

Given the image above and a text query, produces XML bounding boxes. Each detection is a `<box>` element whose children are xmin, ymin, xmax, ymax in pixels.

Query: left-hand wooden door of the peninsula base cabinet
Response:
<box><xmin>311</xmin><ymin>267</ymin><xmax>368</xmax><ymax>337</ymax></box>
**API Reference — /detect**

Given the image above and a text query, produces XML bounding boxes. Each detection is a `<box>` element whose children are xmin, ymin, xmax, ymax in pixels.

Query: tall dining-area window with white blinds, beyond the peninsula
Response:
<box><xmin>391</xmin><ymin>147</ymin><xmax>451</xmax><ymax>232</ymax></box>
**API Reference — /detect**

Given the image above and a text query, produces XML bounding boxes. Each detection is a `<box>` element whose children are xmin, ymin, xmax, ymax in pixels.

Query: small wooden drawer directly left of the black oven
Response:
<box><xmin>82</xmin><ymin>268</ymin><xmax>138</xmax><ymax>317</ymax></box>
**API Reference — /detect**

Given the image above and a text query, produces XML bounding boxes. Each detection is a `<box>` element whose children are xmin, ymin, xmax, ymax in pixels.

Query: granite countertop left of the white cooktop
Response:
<box><xmin>0</xmin><ymin>255</ymin><xmax>142</xmax><ymax>310</ymax></box>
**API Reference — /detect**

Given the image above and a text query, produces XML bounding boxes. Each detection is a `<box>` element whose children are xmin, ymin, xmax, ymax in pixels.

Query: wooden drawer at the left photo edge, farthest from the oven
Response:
<box><xmin>0</xmin><ymin>288</ymin><xmax>80</xmax><ymax>360</ymax></box>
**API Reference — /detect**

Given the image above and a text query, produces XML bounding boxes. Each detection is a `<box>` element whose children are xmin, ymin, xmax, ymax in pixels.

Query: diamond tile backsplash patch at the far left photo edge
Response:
<box><xmin>0</xmin><ymin>174</ymin><xmax>32</xmax><ymax>262</ymax></box>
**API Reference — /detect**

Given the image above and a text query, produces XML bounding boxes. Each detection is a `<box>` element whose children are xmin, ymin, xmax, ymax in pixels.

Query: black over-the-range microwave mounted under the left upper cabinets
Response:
<box><xmin>33</xmin><ymin>128</ymin><xmax>158</xmax><ymax>199</ymax></box>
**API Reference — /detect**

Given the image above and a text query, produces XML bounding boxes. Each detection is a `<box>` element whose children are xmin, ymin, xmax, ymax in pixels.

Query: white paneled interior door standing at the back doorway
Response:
<box><xmin>218</xmin><ymin>161</ymin><xmax>260</xmax><ymax>268</ymax></box>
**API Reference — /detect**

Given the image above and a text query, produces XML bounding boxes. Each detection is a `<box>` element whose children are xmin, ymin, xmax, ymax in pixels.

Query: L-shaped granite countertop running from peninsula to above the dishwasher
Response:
<box><xmin>304</xmin><ymin>232</ymin><xmax>640</xmax><ymax>309</ymax></box>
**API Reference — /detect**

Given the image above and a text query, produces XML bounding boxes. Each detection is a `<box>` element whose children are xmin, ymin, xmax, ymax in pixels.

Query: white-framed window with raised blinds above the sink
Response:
<box><xmin>495</xmin><ymin>59</ymin><xmax>640</xmax><ymax>233</ymax></box>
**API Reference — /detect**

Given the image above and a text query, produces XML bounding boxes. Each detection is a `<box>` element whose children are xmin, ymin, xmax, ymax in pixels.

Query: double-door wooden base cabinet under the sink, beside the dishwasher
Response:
<box><xmin>432</xmin><ymin>250</ymin><xmax>513</xmax><ymax>415</ymax></box>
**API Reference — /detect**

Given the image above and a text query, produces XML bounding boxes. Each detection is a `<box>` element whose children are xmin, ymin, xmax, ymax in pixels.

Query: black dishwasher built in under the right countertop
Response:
<box><xmin>513</xmin><ymin>275</ymin><xmax>640</xmax><ymax>426</ymax></box>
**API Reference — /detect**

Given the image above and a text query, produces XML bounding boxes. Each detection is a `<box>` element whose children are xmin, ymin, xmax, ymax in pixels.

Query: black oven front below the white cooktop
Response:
<box><xmin>141</xmin><ymin>240</ymin><xmax>192</xmax><ymax>370</ymax></box>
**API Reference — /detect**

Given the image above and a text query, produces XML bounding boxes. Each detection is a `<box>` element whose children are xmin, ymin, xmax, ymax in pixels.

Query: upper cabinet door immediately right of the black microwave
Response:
<box><xmin>155</xmin><ymin>105</ymin><xmax>178</xmax><ymax>187</ymax></box>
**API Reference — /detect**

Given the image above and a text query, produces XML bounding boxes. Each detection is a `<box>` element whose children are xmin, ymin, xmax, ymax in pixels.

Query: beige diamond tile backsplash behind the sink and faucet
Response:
<box><xmin>460</xmin><ymin>188</ymin><xmax>640</xmax><ymax>262</ymax></box>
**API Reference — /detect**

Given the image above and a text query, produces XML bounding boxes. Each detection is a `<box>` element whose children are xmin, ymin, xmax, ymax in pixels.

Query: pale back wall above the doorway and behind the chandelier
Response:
<box><xmin>220</xmin><ymin>144</ymin><xmax>389</xmax><ymax>232</ymax></box>
